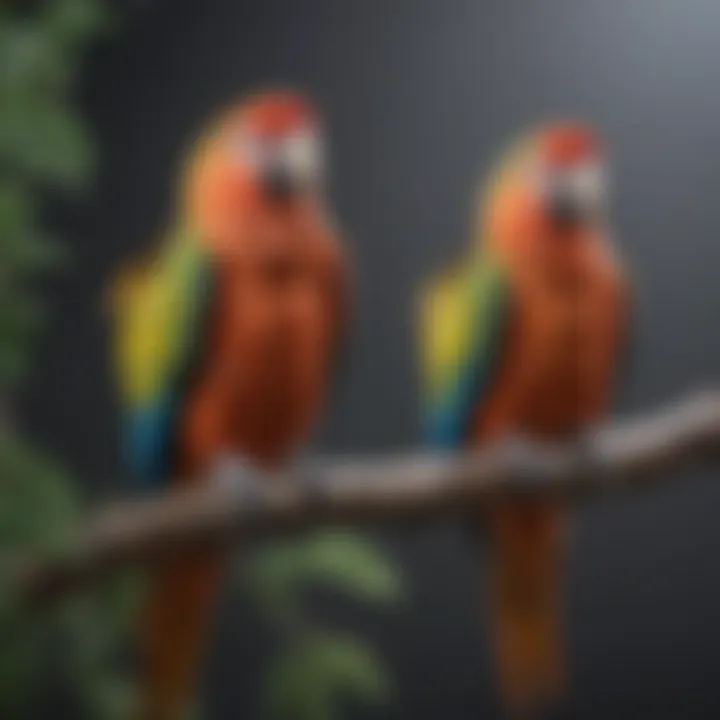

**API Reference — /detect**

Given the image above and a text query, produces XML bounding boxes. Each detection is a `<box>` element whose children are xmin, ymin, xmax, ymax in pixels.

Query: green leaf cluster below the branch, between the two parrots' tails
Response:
<box><xmin>247</xmin><ymin>531</ymin><xmax>403</xmax><ymax>720</ymax></box>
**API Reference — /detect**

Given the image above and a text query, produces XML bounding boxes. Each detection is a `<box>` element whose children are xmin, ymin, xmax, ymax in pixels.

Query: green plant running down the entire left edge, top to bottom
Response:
<box><xmin>0</xmin><ymin>0</ymin><xmax>141</xmax><ymax>720</ymax></box>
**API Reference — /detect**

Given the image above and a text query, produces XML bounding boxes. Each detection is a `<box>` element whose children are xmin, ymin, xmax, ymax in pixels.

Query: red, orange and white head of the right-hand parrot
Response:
<box><xmin>482</xmin><ymin>123</ymin><xmax>606</xmax><ymax>255</ymax></box>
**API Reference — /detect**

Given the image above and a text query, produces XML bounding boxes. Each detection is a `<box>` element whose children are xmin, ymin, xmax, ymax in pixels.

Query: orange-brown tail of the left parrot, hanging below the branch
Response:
<box><xmin>139</xmin><ymin>555</ymin><xmax>222</xmax><ymax>720</ymax></box>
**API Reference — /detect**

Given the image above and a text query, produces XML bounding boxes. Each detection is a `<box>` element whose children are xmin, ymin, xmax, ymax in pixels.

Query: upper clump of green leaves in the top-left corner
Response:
<box><xmin>0</xmin><ymin>0</ymin><xmax>107</xmax><ymax>396</ymax></box>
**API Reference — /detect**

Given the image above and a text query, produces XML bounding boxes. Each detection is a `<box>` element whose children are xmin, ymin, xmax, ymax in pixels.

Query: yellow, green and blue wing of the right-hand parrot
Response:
<box><xmin>420</xmin><ymin>257</ymin><xmax>511</xmax><ymax>447</ymax></box>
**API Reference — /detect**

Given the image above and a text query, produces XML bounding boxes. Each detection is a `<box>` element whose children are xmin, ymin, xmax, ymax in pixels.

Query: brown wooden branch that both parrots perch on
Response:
<box><xmin>18</xmin><ymin>391</ymin><xmax>720</xmax><ymax>601</ymax></box>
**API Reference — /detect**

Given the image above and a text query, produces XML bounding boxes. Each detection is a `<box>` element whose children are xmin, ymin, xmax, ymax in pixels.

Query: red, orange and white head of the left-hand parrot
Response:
<box><xmin>186</xmin><ymin>91</ymin><xmax>323</xmax><ymax>236</ymax></box>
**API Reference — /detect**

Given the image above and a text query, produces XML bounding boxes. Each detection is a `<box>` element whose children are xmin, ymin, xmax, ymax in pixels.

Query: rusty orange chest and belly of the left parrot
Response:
<box><xmin>180</xmin><ymin>239</ymin><xmax>334</xmax><ymax>470</ymax></box>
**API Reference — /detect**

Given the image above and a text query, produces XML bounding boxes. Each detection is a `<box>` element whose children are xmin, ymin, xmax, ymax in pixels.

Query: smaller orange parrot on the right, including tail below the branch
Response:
<box><xmin>419</xmin><ymin>121</ymin><xmax>630</xmax><ymax>717</ymax></box>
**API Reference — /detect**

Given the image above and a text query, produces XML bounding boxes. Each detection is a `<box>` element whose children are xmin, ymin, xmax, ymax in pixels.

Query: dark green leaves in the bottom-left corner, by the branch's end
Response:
<box><xmin>0</xmin><ymin>436</ymin><xmax>141</xmax><ymax>720</ymax></box>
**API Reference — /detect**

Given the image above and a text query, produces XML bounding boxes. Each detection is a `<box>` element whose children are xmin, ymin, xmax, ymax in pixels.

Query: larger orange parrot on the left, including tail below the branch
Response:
<box><xmin>113</xmin><ymin>89</ymin><xmax>348</xmax><ymax>720</ymax></box>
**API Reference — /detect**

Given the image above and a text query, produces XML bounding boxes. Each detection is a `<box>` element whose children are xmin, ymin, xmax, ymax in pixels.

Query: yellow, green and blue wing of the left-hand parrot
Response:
<box><xmin>114</xmin><ymin>231</ymin><xmax>214</xmax><ymax>484</ymax></box>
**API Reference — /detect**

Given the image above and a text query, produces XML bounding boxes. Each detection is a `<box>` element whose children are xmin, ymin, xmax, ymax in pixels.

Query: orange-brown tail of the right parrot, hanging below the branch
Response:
<box><xmin>490</xmin><ymin>501</ymin><xmax>565</xmax><ymax>718</ymax></box>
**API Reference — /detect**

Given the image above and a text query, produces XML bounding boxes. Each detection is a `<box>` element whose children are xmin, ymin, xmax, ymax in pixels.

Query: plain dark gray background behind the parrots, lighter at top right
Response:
<box><xmin>25</xmin><ymin>0</ymin><xmax>720</xmax><ymax>720</ymax></box>
